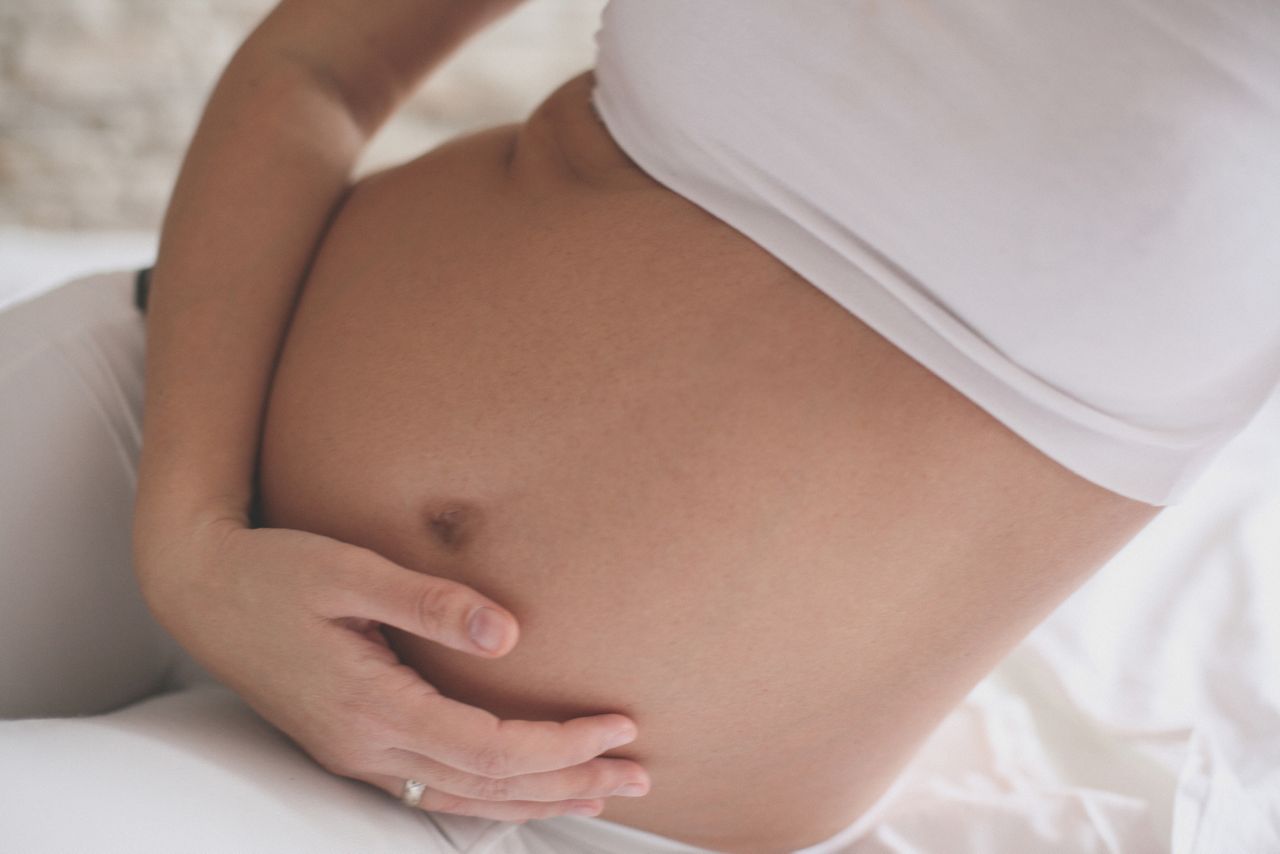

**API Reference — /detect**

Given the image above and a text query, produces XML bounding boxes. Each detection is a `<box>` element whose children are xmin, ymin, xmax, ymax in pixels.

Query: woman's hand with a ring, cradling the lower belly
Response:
<box><xmin>134</xmin><ymin>516</ymin><xmax>649</xmax><ymax>822</ymax></box>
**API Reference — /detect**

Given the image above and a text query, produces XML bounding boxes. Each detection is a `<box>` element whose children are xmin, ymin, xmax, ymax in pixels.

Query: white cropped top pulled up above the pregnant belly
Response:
<box><xmin>593</xmin><ymin>0</ymin><xmax>1280</xmax><ymax>504</ymax></box>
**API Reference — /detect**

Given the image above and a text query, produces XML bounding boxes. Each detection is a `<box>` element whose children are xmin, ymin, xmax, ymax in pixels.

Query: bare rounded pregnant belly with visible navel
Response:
<box><xmin>260</xmin><ymin>72</ymin><xmax>1160</xmax><ymax>853</ymax></box>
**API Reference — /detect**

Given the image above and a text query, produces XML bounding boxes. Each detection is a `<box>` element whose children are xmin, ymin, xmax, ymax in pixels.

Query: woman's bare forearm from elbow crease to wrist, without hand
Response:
<box><xmin>138</xmin><ymin>58</ymin><xmax>364</xmax><ymax>530</ymax></box>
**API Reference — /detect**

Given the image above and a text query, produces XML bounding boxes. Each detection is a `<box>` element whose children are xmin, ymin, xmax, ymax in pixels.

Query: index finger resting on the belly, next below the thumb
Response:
<box><xmin>399</xmin><ymin>694</ymin><xmax>636</xmax><ymax>777</ymax></box>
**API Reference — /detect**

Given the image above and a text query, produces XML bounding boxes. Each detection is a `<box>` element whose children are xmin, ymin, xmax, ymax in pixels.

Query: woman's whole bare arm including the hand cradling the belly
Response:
<box><xmin>134</xmin><ymin>0</ymin><xmax>645</xmax><ymax>821</ymax></box>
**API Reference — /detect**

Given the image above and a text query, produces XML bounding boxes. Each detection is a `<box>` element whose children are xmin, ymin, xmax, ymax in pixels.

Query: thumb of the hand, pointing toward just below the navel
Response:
<box><xmin>326</xmin><ymin>549</ymin><xmax>520</xmax><ymax>658</ymax></box>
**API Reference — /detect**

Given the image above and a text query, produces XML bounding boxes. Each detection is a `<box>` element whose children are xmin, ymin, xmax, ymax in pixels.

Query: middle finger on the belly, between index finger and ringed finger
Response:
<box><xmin>372</xmin><ymin>748</ymin><xmax>649</xmax><ymax>802</ymax></box>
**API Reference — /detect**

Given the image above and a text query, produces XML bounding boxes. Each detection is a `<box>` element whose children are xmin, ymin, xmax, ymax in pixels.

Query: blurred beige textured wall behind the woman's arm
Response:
<box><xmin>0</xmin><ymin>0</ymin><xmax>604</xmax><ymax>229</ymax></box>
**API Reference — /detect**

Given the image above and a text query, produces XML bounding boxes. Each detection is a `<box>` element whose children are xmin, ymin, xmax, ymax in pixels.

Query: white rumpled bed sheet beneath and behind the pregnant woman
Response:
<box><xmin>0</xmin><ymin>228</ymin><xmax>1280</xmax><ymax>854</ymax></box>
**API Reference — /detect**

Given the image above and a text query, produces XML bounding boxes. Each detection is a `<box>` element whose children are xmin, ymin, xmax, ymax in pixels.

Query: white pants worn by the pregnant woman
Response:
<box><xmin>0</xmin><ymin>270</ymin><xmax>887</xmax><ymax>854</ymax></box>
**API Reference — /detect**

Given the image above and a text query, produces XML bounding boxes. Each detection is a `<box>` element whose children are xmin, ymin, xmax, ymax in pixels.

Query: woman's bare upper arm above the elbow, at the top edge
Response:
<box><xmin>241</xmin><ymin>0</ymin><xmax>524</xmax><ymax>137</ymax></box>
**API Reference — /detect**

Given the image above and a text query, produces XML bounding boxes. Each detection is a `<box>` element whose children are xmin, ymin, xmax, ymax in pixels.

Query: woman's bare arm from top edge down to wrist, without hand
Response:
<box><xmin>137</xmin><ymin>0</ymin><xmax>513</xmax><ymax>550</ymax></box>
